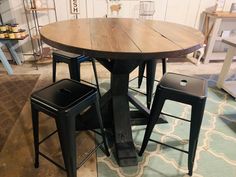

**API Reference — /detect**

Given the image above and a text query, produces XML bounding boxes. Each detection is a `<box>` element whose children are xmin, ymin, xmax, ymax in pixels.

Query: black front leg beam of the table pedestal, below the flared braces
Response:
<box><xmin>111</xmin><ymin>74</ymin><xmax>137</xmax><ymax>166</ymax></box>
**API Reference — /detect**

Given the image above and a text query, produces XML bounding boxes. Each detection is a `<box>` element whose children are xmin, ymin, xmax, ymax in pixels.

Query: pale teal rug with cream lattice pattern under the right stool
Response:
<box><xmin>97</xmin><ymin>75</ymin><xmax>236</xmax><ymax>177</ymax></box>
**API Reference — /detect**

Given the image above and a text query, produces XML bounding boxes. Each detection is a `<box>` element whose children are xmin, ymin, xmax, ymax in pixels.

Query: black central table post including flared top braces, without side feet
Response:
<box><xmin>95</xmin><ymin>59</ymin><xmax>142</xmax><ymax>166</ymax></box>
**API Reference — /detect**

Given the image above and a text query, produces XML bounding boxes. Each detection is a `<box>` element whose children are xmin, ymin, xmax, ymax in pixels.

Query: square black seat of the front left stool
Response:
<box><xmin>32</xmin><ymin>79</ymin><xmax>96</xmax><ymax>110</ymax></box>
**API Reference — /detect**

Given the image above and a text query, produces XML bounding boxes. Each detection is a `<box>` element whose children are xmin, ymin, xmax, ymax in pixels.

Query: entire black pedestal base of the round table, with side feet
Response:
<box><xmin>77</xmin><ymin>58</ymin><xmax>166</xmax><ymax>166</ymax></box>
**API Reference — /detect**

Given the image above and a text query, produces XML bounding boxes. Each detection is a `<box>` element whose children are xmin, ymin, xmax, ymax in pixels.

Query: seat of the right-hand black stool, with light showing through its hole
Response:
<box><xmin>159</xmin><ymin>73</ymin><xmax>207</xmax><ymax>97</ymax></box>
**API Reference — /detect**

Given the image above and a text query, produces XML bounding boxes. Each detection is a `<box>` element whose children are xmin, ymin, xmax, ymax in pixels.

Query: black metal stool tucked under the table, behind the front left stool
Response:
<box><xmin>52</xmin><ymin>50</ymin><xmax>101</xmax><ymax>97</ymax></box>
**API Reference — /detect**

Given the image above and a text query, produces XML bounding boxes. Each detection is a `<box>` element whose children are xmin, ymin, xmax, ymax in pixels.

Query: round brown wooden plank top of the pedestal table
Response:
<box><xmin>40</xmin><ymin>18</ymin><xmax>204</xmax><ymax>59</ymax></box>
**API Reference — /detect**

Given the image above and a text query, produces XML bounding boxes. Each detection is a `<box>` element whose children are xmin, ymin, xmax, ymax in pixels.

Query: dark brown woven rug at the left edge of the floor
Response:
<box><xmin>0</xmin><ymin>74</ymin><xmax>39</xmax><ymax>151</ymax></box>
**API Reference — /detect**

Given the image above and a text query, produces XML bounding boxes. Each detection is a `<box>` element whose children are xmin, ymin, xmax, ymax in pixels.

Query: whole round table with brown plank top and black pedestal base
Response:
<box><xmin>40</xmin><ymin>18</ymin><xmax>204</xmax><ymax>166</ymax></box>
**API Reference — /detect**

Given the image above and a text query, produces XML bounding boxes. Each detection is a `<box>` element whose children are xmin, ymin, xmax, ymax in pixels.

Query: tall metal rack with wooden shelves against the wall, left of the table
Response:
<box><xmin>23</xmin><ymin>0</ymin><xmax>57</xmax><ymax>68</ymax></box>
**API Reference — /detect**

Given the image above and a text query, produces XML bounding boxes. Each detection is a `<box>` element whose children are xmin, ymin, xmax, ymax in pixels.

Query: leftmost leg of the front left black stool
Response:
<box><xmin>31</xmin><ymin>103</ymin><xmax>39</xmax><ymax>168</ymax></box>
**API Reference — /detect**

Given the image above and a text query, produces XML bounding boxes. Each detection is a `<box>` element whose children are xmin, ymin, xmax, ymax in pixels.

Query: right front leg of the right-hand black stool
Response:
<box><xmin>188</xmin><ymin>100</ymin><xmax>205</xmax><ymax>176</ymax></box>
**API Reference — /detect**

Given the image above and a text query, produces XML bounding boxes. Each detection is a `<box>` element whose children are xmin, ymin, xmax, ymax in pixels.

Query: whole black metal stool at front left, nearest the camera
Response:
<box><xmin>31</xmin><ymin>79</ymin><xmax>109</xmax><ymax>177</ymax></box>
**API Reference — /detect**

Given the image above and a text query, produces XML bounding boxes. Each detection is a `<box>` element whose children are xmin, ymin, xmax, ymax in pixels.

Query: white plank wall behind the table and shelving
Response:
<box><xmin>3</xmin><ymin>0</ymin><xmax>236</xmax><ymax>52</ymax></box>
